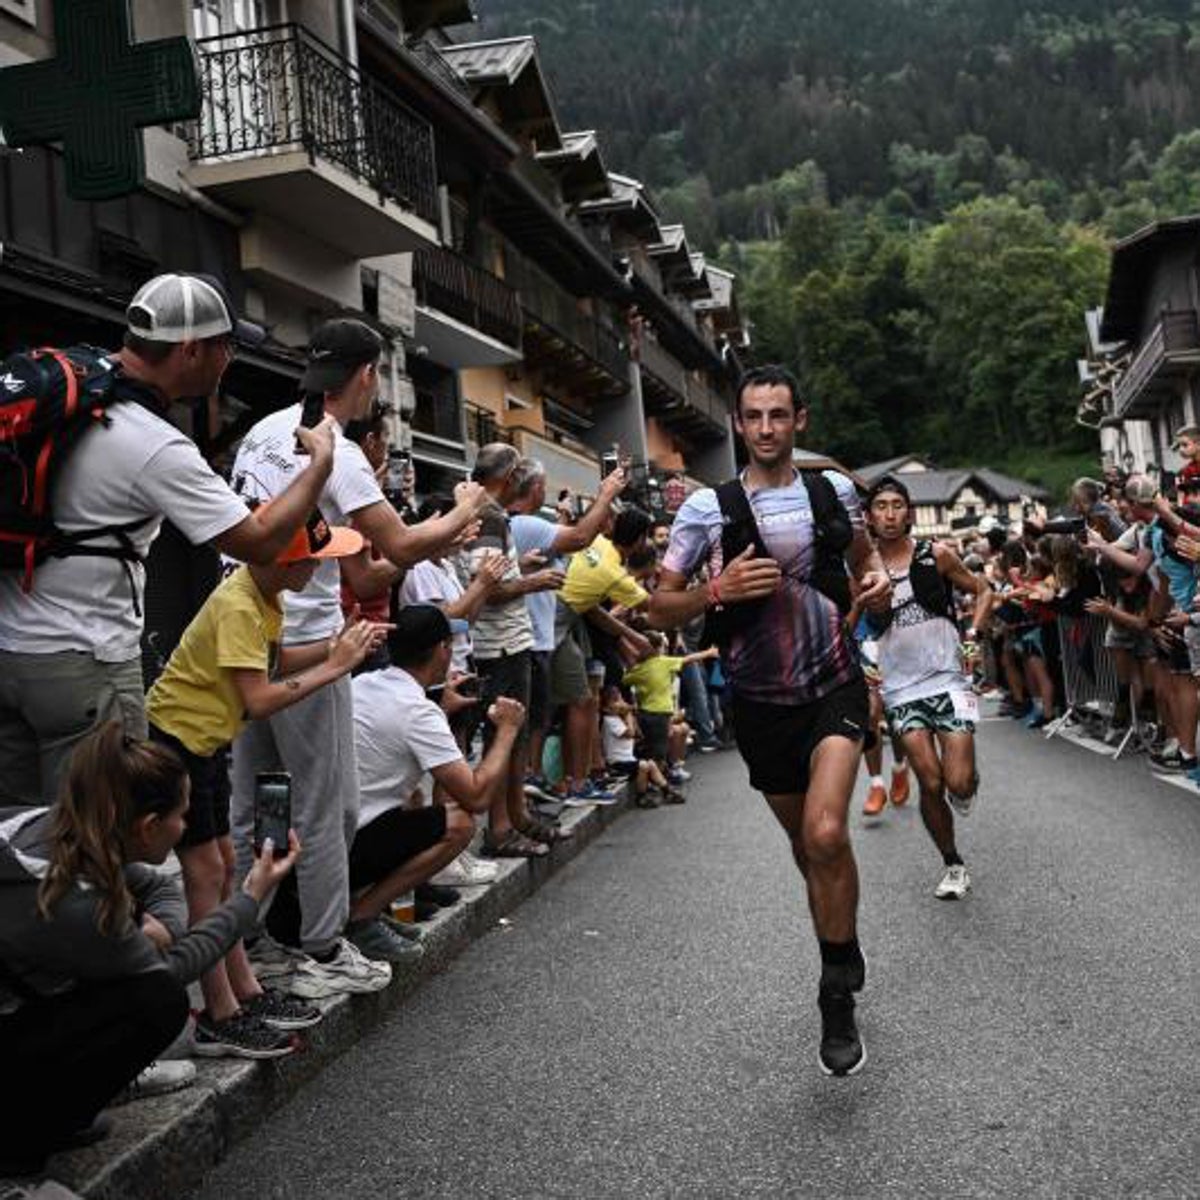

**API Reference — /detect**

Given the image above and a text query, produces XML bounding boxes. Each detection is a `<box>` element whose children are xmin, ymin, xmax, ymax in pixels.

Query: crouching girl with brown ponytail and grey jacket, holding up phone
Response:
<box><xmin>0</xmin><ymin>721</ymin><xmax>300</xmax><ymax>1176</ymax></box>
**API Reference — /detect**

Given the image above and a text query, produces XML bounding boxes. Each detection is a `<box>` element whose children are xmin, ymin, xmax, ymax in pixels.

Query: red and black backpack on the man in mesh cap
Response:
<box><xmin>0</xmin><ymin>346</ymin><xmax>155</xmax><ymax>595</ymax></box>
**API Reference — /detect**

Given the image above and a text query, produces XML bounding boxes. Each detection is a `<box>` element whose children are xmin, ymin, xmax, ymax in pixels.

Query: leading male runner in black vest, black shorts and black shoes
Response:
<box><xmin>650</xmin><ymin>366</ymin><xmax>890</xmax><ymax>1075</ymax></box>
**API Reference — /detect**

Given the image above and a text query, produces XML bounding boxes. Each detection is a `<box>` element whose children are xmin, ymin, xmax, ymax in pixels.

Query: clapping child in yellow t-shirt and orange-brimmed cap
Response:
<box><xmin>146</xmin><ymin>512</ymin><xmax>388</xmax><ymax>1058</ymax></box>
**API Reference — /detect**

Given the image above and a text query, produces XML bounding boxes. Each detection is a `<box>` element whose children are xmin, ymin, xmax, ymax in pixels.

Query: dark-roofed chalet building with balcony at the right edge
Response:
<box><xmin>1079</xmin><ymin>216</ymin><xmax>1200</xmax><ymax>473</ymax></box>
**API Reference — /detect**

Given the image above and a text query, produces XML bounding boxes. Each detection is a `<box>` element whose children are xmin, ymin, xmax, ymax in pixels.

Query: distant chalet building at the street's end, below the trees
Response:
<box><xmin>854</xmin><ymin>455</ymin><xmax>1049</xmax><ymax>538</ymax></box>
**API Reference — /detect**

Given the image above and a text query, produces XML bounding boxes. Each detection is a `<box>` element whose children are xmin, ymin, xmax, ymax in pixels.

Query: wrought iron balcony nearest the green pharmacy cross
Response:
<box><xmin>190</xmin><ymin>24</ymin><xmax>438</xmax><ymax>257</ymax></box>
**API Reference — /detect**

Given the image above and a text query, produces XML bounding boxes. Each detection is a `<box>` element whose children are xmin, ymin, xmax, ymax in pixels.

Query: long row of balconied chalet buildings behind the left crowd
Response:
<box><xmin>0</xmin><ymin>0</ymin><xmax>746</xmax><ymax>493</ymax></box>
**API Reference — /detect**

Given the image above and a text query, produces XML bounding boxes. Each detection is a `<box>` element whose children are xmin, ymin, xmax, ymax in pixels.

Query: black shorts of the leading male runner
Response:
<box><xmin>733</xmin><ymin>679</ymin><xmax>870</xmax><ymax>796</ymax></box>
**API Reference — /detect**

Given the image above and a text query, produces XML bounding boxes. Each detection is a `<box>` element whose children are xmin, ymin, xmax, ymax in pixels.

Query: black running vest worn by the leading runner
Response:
<box><xmin>704</xmin><ymin>470</ymin><xmax>854</xmax><ymax>646</ymax></box>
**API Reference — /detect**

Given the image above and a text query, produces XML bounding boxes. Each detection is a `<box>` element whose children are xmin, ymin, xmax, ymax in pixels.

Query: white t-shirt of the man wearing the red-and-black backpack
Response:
<box><xmin>0</xmin><ymin>401</ymin><xmax>246</xmax><ymax>662</ymax></box>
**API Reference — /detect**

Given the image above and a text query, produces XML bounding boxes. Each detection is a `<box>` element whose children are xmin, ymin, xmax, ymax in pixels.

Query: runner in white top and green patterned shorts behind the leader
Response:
<box><xmin>866</xmin><ymin>475</ymin><xmax>991</xmax><ymax>900</ymax></box>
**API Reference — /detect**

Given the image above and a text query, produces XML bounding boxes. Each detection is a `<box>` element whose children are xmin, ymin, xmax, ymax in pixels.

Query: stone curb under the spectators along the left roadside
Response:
<box><xmin>47</xmin><ymin>794</ymin><xmax>630</xmax><ymax>1200</ymax></box>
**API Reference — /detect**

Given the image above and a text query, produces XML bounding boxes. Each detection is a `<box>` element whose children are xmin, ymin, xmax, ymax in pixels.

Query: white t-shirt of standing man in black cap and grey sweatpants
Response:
<box><xmin>233</xmin><ymin>404</ymin><xmax>384</xmax><ymax>646</ymax></box>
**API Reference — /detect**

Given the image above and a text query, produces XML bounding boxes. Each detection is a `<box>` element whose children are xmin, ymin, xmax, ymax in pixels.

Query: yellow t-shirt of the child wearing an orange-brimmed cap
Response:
<box><xmin>146</xmin><ymin>566</ymin><xmax>283</xmax><ymax>757</ymax></box>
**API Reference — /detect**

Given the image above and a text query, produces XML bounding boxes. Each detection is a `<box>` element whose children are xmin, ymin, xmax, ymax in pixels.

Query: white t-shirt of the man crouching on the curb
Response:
<box><xmin>350</xmin><ymin>667</ymin><xmax>462</xmax><ymax>829</ymax></box>
